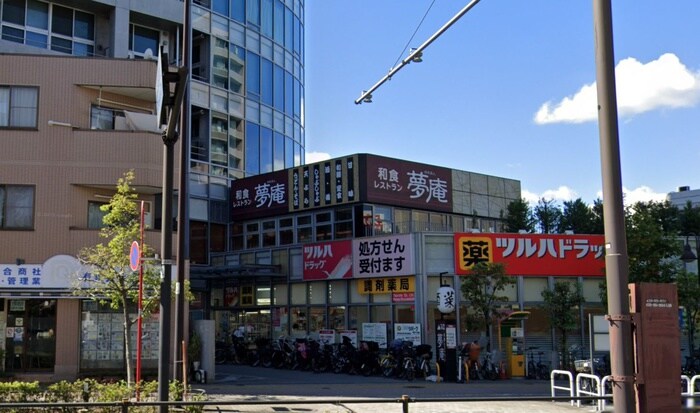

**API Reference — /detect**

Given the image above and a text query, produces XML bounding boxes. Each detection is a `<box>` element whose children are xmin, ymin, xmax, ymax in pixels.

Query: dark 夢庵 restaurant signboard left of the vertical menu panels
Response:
<box><xmin>230</xmin><ymin>171</ymin><xmax>289</xmax><ymax>221</ymax></box>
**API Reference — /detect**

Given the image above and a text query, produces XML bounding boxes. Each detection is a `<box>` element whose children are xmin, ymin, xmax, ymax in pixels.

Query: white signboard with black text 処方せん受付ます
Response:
<box><xmin>352</xmin><ymin>234</ymin><xmax>415</xmax><ymax>278</ymax></box>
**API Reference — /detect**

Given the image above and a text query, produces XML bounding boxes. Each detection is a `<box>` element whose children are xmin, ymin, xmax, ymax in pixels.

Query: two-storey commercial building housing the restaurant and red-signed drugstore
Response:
<box><xmin>191</xmin><ymin>154</ymin><xmax>604</xmax><ymax>376</ymax></box>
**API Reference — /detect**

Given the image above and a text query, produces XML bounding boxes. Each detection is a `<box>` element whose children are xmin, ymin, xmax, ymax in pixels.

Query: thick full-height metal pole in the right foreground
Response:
<box><xmin>593</xmin><ymin>0</ymin><xmax>636</xmax><ymax>413</ymax></box>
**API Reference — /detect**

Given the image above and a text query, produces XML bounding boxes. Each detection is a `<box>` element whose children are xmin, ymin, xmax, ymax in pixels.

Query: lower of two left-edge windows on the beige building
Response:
<box><xmin>0</xmin><ymin>185</ymin><xmax>34</xmax><ymax>229</ymax></box>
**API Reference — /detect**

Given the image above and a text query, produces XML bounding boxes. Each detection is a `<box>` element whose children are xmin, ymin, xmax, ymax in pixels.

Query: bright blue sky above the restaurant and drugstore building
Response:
<box><xmin>305</xmin><ymin>0</ymin><xmax>700</xmax><ymax>204</ymax></box>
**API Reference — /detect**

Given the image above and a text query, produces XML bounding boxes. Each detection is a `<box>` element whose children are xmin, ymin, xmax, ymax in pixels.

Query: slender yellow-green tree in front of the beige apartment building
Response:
<box><xmin>74</xmin><ymin>171</ymin><xmax>160</xmax><ymax>385</ymax></box>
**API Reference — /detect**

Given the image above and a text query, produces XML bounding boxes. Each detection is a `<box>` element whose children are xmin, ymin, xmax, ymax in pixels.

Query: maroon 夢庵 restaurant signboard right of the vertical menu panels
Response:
<box><xmin>363</xmin><ymin>155</ymin><xmax>452</xmax><ymax>212</ymax></box>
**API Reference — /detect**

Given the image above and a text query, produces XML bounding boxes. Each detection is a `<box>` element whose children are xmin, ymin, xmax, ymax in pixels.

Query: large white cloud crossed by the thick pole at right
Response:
<box><xmin>534</xmin><ymin>53</ymin><xmax>700</xmax><ymax>125</ymax></box>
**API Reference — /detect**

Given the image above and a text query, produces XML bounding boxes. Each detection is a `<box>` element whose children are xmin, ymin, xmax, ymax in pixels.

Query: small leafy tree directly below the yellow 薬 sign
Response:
<box><xmin>461</xmin><ymin>262</ymin><xmax>515</xmax><ymax>346</ymax></box>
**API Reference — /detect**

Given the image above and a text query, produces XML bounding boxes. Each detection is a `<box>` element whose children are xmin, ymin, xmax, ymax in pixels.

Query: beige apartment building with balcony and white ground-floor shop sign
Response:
<box><xmin>0</xmin><ymin>54</ymin><xmax>170</xmax><ymax>380</ymax></box>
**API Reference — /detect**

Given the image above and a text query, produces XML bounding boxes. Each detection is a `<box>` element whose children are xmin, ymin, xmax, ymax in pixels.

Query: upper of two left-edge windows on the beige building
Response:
<box><xmin>0</xmin><ymin>86</ymin><xmax>39</xmax><ymax>128</ymax></box>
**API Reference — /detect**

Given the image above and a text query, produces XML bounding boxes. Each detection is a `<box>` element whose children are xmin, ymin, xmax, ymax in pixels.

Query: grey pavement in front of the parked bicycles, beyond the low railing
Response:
<box><xmin>192</xmin><ymin>365</ymin><xmax>600</xmax><ymax>413</ymax></box>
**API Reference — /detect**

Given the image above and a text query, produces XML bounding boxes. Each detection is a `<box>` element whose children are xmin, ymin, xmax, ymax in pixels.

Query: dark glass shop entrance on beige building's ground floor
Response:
<box><xmin>5</xmin><ymin>299</ymin><xmax>56</xmax><ymax>372</ymax></box>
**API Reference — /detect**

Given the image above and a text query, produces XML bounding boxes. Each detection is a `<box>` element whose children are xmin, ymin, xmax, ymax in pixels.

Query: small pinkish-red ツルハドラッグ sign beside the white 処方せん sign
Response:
<box><xmin>303</xmin><ymin>240</ymin><xmax>352</xmax><ymax>280</ymax></box>
